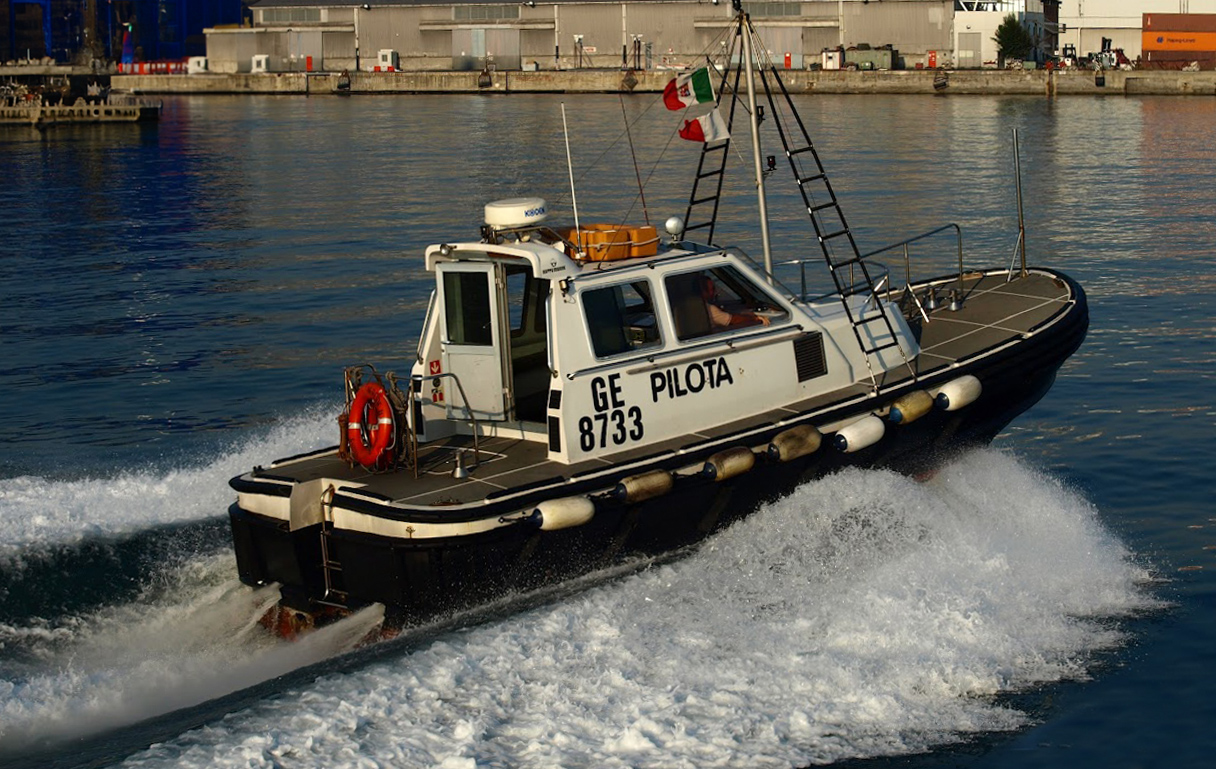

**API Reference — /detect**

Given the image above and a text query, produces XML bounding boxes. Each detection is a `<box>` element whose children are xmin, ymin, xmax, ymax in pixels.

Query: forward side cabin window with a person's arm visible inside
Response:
<box><xmin>664</xmin><ymin>266</ymin><xmax>789</xmax><ymax>342</ymax></box>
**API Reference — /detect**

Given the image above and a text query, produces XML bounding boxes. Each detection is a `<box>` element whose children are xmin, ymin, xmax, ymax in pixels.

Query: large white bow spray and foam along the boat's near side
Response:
<box><xmin>85</xmin><ymin>451</ymin><xmax>1155</xmax><ymax>768</ymax></box>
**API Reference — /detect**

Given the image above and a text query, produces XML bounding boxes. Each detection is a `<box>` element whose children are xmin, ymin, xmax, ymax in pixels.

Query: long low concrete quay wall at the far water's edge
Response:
<box><xmin>111</xmin><ymin>69</ymin><xmax>1216</xmax><ymax>96</ymax></box>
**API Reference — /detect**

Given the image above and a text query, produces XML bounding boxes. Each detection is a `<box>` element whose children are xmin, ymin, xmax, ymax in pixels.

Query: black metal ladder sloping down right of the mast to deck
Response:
<box><xmin>756</xmin><ymin>63</ymin><xmax>916</xmax><ymax>389</ymax></box>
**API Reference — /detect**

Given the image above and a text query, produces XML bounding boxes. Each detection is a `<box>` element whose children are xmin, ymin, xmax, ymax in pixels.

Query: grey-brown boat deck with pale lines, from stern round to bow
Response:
<box><xmin>259</xmin><ymin>267</ymin><xmax>1074</xmax><ymax>506</ymax></box>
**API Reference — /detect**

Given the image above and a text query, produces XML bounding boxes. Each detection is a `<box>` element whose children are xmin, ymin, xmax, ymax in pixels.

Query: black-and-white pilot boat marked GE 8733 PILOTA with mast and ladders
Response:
<box><xmin>230</xmin><ymin>7</ymin><xmax>1088</xmax><ymax>635</ymax></box>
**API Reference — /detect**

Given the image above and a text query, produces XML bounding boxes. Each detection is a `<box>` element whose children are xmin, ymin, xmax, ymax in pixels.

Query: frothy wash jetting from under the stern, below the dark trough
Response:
<box><xmin>0</xmin><ymin>555</ymin><xmax>383</xmax><ymax>754</ymax></box>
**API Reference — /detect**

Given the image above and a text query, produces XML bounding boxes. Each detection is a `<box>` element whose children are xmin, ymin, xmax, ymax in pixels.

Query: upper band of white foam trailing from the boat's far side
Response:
<box><xmin>0</xmin><ymin>406</ymin><xmax>337</xmax><ymax>566</ymax></box>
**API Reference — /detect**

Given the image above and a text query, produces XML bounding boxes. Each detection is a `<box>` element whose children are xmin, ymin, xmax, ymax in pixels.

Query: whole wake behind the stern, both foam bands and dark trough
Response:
<box><xmin>0</xmin><ymin>408</ymin><xmax>381</xmax><ymax>759</ymax></box>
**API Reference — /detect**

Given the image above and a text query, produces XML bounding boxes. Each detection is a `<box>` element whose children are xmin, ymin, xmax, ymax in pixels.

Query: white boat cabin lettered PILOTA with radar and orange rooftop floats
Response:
<box><xmin>412</xmin><ymin>198</ymin><xmax>917</xmax><ymax>464</ymax></box>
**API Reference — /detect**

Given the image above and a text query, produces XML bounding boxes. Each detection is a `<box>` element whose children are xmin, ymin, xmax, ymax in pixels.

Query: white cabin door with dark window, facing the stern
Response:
<box><xmin>435</xmin><ymin>262</ymin><xmax>510</xmax><ymax>420</ymax></box>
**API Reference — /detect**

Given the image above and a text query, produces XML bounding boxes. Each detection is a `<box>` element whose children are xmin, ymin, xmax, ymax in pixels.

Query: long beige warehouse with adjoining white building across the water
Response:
<box><xmin>199</xmin><ymin>0</ymin><xmax>1036</xmax><ymax>73</ymax></box>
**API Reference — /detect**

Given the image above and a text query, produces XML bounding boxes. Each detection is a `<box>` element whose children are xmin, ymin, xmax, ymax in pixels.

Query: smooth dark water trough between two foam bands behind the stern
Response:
<box><xmin>0</xmin><ymin>517</ymin><xmax>231</xmax><ymax>623</ymax></box>
